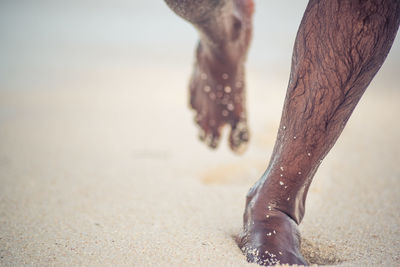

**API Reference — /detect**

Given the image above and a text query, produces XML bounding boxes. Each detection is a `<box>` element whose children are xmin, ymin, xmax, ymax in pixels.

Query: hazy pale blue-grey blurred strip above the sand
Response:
<box><xmin>0</xmin><ymin>0</ymin><xmax>400</xmax><ymax>91</ymax></box>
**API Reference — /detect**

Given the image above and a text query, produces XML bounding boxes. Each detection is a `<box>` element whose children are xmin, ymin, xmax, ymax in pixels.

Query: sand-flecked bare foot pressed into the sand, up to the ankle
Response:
<box><xmin>237</xmin><ymin>187</ymin><xmax>307</xmax><ymax>266</ymax></box>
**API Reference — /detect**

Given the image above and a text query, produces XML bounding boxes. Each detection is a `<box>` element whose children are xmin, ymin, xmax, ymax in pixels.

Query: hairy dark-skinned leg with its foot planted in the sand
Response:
<box><xmin>238</xmin><ymin>0</ymin><xmax>400</xmax><ymax>265</ymax></box>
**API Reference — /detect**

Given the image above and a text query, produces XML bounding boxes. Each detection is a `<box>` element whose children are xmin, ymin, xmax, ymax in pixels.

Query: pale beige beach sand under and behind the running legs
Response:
<box><xmin>0</xmin><ymin>1</ymin><xmax>400</xmax><ymax>266</ymax></box>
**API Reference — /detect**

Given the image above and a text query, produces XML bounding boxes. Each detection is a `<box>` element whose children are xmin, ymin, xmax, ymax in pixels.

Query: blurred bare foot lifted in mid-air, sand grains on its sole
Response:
<box><xmin>189</xmin><ymin>0</ymin><xmax>253</xmax><ymax>152</ymax></box>
